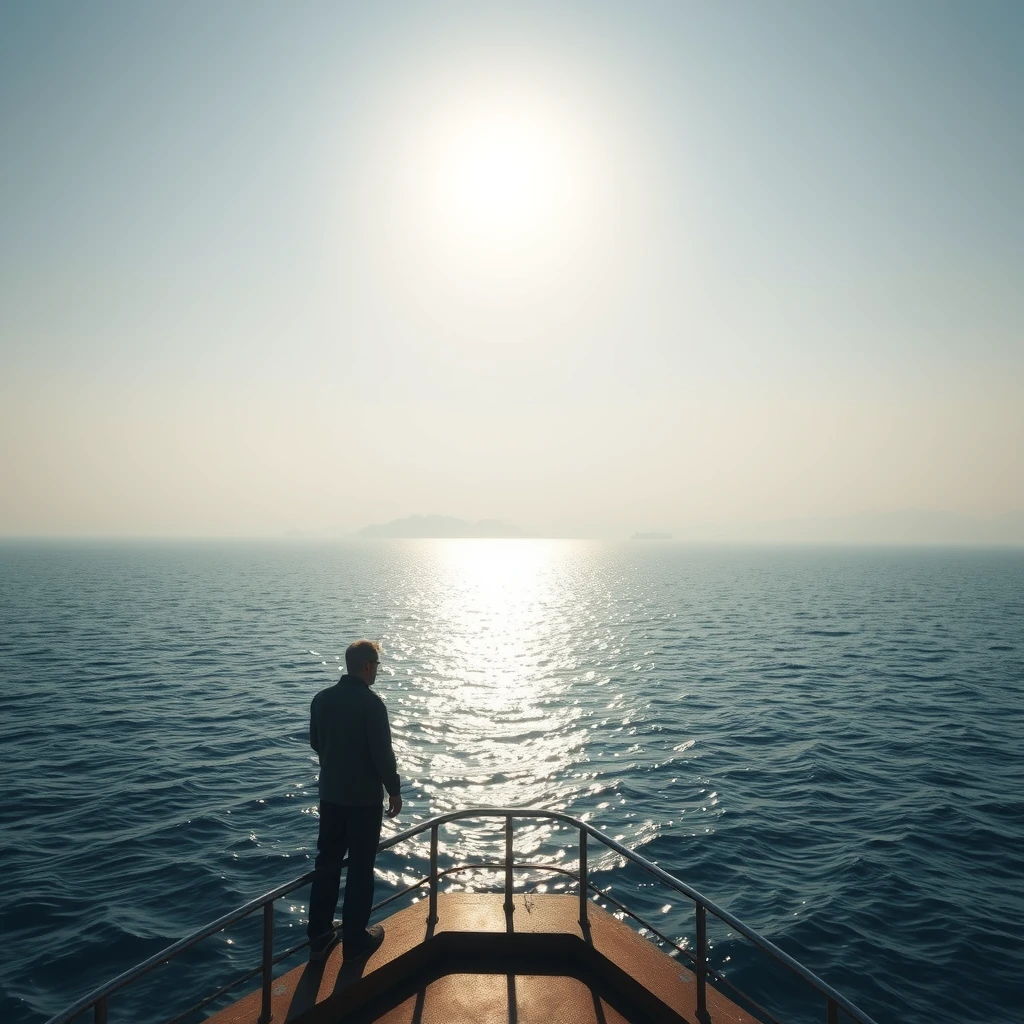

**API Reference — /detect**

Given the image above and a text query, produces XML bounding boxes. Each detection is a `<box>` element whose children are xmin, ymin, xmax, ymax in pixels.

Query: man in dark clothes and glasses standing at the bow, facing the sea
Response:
<box><xmin>307</xmin><ymin>640</ymin><xmax>401</xmax><ymax>962</ymax></box>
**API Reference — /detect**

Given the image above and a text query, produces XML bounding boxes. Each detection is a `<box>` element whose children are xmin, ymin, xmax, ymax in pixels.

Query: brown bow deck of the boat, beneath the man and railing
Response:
<box><xmin>205</xmin><ymin>893</ymin><xmax>757</xmax><ymax>1024</ymax></box>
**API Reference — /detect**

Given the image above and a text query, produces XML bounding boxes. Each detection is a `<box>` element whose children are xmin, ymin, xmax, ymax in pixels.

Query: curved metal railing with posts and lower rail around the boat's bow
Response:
<box><xmin>48</xmin><ymin>807</ymin><xmax>876</xmax><ymax>1024</ymax></box>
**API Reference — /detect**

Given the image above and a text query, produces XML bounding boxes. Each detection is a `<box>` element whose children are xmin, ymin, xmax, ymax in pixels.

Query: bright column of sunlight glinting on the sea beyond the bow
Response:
<box><xmin>376</xmin><ymin>541</ymin><xmax>593</xmax><ymax>885</ymax></box>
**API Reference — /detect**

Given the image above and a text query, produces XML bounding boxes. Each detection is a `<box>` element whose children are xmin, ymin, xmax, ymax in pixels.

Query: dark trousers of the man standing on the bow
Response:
<box><xmin>306</xmin><ymin>801</ymin><xmax>384</xmax><ymax>948</ymax></box>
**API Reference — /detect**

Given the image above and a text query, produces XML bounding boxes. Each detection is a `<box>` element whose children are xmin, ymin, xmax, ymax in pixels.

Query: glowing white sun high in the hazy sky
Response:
<box><xmin>360</xmin><ymin>59</ymin><xmax>613</xmax><ymax>308</ymax></box>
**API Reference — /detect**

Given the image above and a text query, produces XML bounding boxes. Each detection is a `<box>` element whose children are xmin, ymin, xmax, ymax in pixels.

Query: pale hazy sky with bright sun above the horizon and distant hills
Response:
<box><xmin>0</xmin><ymin>0</ymin><xmax>1024</xmax><ymax>536</ymax></box>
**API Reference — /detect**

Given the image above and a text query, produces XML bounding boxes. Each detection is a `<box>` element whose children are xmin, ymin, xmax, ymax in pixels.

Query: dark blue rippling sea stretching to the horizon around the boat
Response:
<box><xmin>0</xmin><ymin>541</ymin><xmax>1024</xmax><ymax>1024</ymax></box>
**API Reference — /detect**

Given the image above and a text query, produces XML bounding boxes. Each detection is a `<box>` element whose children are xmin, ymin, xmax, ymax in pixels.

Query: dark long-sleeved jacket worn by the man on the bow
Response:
<box><xmin>309</xmin><ymin>676</ymin><xmax>401</xmax><ymax>807</ymax></box>
